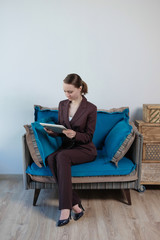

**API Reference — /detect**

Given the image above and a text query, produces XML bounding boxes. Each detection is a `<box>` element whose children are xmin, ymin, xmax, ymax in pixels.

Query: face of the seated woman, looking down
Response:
<box><xmin>63</xmin><ymin>83</ymin><xmax>82</xmax><ymax>101</ymax></box>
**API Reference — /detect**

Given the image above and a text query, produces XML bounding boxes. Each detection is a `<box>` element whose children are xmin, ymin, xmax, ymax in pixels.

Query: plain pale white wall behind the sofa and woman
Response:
<box><xmin>0</xmin><ymin>0</ymin><xmax>160</xmax><ymax>174</ymax></box>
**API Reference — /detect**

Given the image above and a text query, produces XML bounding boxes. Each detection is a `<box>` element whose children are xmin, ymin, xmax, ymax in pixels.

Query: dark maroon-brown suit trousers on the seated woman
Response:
<box><xmin>46</xmin><ymin>147</ymin><xmax>96</xmax><ymax>210</ymax></box>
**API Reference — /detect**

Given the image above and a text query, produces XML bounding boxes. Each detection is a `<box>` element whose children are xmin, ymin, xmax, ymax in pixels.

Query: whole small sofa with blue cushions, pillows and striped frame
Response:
<box><xmin>22</xmin><ymin>105</ymin><xmax>144</xmax><ymax>205</ymax></box>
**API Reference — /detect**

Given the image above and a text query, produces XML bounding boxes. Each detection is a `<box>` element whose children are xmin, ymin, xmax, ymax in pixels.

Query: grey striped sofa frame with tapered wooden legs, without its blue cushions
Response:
<box><xmin>22</xmin><ymin>127</ymin><xmax>144</xmax><ymax>206</ymax></box>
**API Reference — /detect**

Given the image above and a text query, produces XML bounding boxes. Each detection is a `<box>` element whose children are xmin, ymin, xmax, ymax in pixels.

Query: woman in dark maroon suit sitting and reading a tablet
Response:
<box><xmin>45</xmin><ymin>74</ymin><xmax>97</xmax><ymax>226</ymax></box>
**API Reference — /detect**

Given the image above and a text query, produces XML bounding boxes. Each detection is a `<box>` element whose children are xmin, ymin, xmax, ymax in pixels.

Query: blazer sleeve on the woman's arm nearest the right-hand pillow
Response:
<box><xmin>75</xmin><ymin>105</ymin><xmax>97</xmax><ymax>144</ymax></box>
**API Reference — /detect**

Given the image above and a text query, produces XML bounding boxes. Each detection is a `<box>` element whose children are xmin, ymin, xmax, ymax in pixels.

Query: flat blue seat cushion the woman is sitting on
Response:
<box><xmin>26</xmin><ymin>154</ymin><xmax>136</xmax><ymax>177</ymax></box>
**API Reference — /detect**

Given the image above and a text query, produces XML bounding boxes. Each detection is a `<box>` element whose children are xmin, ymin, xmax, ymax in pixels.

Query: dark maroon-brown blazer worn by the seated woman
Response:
<box><xmin>58</xmin><ymin>96</ymin><xmax>97</xmax><ymax>156</ymax></box>
